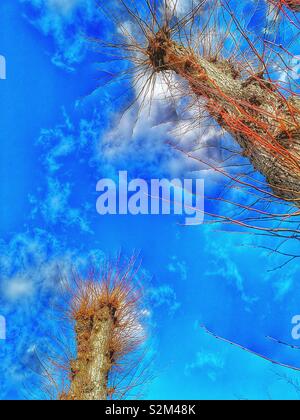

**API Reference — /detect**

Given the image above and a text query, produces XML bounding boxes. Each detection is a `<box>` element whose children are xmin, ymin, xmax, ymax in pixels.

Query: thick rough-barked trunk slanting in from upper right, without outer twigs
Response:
<box><xmin>148</xmin><ymin>28</ymin><xmax>300</xmax><ymax>207</ymax></box>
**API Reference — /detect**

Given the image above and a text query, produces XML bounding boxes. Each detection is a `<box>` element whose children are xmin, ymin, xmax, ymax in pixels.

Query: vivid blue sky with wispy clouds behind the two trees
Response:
<box><xmin>0</xmin><ymin>0</ymin><xmax>300</xmax><ymax>399</ymax></box>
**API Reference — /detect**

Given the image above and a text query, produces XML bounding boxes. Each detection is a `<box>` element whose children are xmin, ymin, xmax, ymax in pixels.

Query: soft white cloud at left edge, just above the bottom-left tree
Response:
<box><xmin>0</xmin><ymin>230</ymin><xmax>104</xmax><ymax>303</ymax></box>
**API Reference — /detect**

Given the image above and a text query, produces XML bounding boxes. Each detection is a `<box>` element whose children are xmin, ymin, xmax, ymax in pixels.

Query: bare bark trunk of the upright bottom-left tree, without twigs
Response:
<box><xmin>61</xmin><ymin>306</ymin><xmax>114</xmax><ymax>400</ymax></box>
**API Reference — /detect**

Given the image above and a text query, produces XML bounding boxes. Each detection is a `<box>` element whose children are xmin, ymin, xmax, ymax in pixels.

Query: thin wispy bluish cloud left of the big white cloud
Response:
<box><xmin>29</xmin><ymin>112</ymin><xmax>99</xmax><ymax>234</ymax></box>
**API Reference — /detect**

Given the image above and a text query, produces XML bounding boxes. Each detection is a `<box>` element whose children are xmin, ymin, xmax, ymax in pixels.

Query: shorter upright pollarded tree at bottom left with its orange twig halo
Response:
<box><xmin>51</xmin><ymin>258</ymin><xmax>148</xmax><ymax>400</ymax></box>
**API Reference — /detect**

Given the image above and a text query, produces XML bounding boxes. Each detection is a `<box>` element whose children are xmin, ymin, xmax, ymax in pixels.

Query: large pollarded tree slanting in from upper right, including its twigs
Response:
<box><xmin>98</xmin><ymin>0</ymin><xmax>300</xmax><ymax>259</ymax></box>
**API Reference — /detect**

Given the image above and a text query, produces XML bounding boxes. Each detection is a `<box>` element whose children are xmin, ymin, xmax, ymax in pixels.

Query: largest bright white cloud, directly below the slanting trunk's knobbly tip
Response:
<box><xmin>99</xmin><ymin>70</ymin><xmax>222</xmax><ymax>177</ymax></box>
